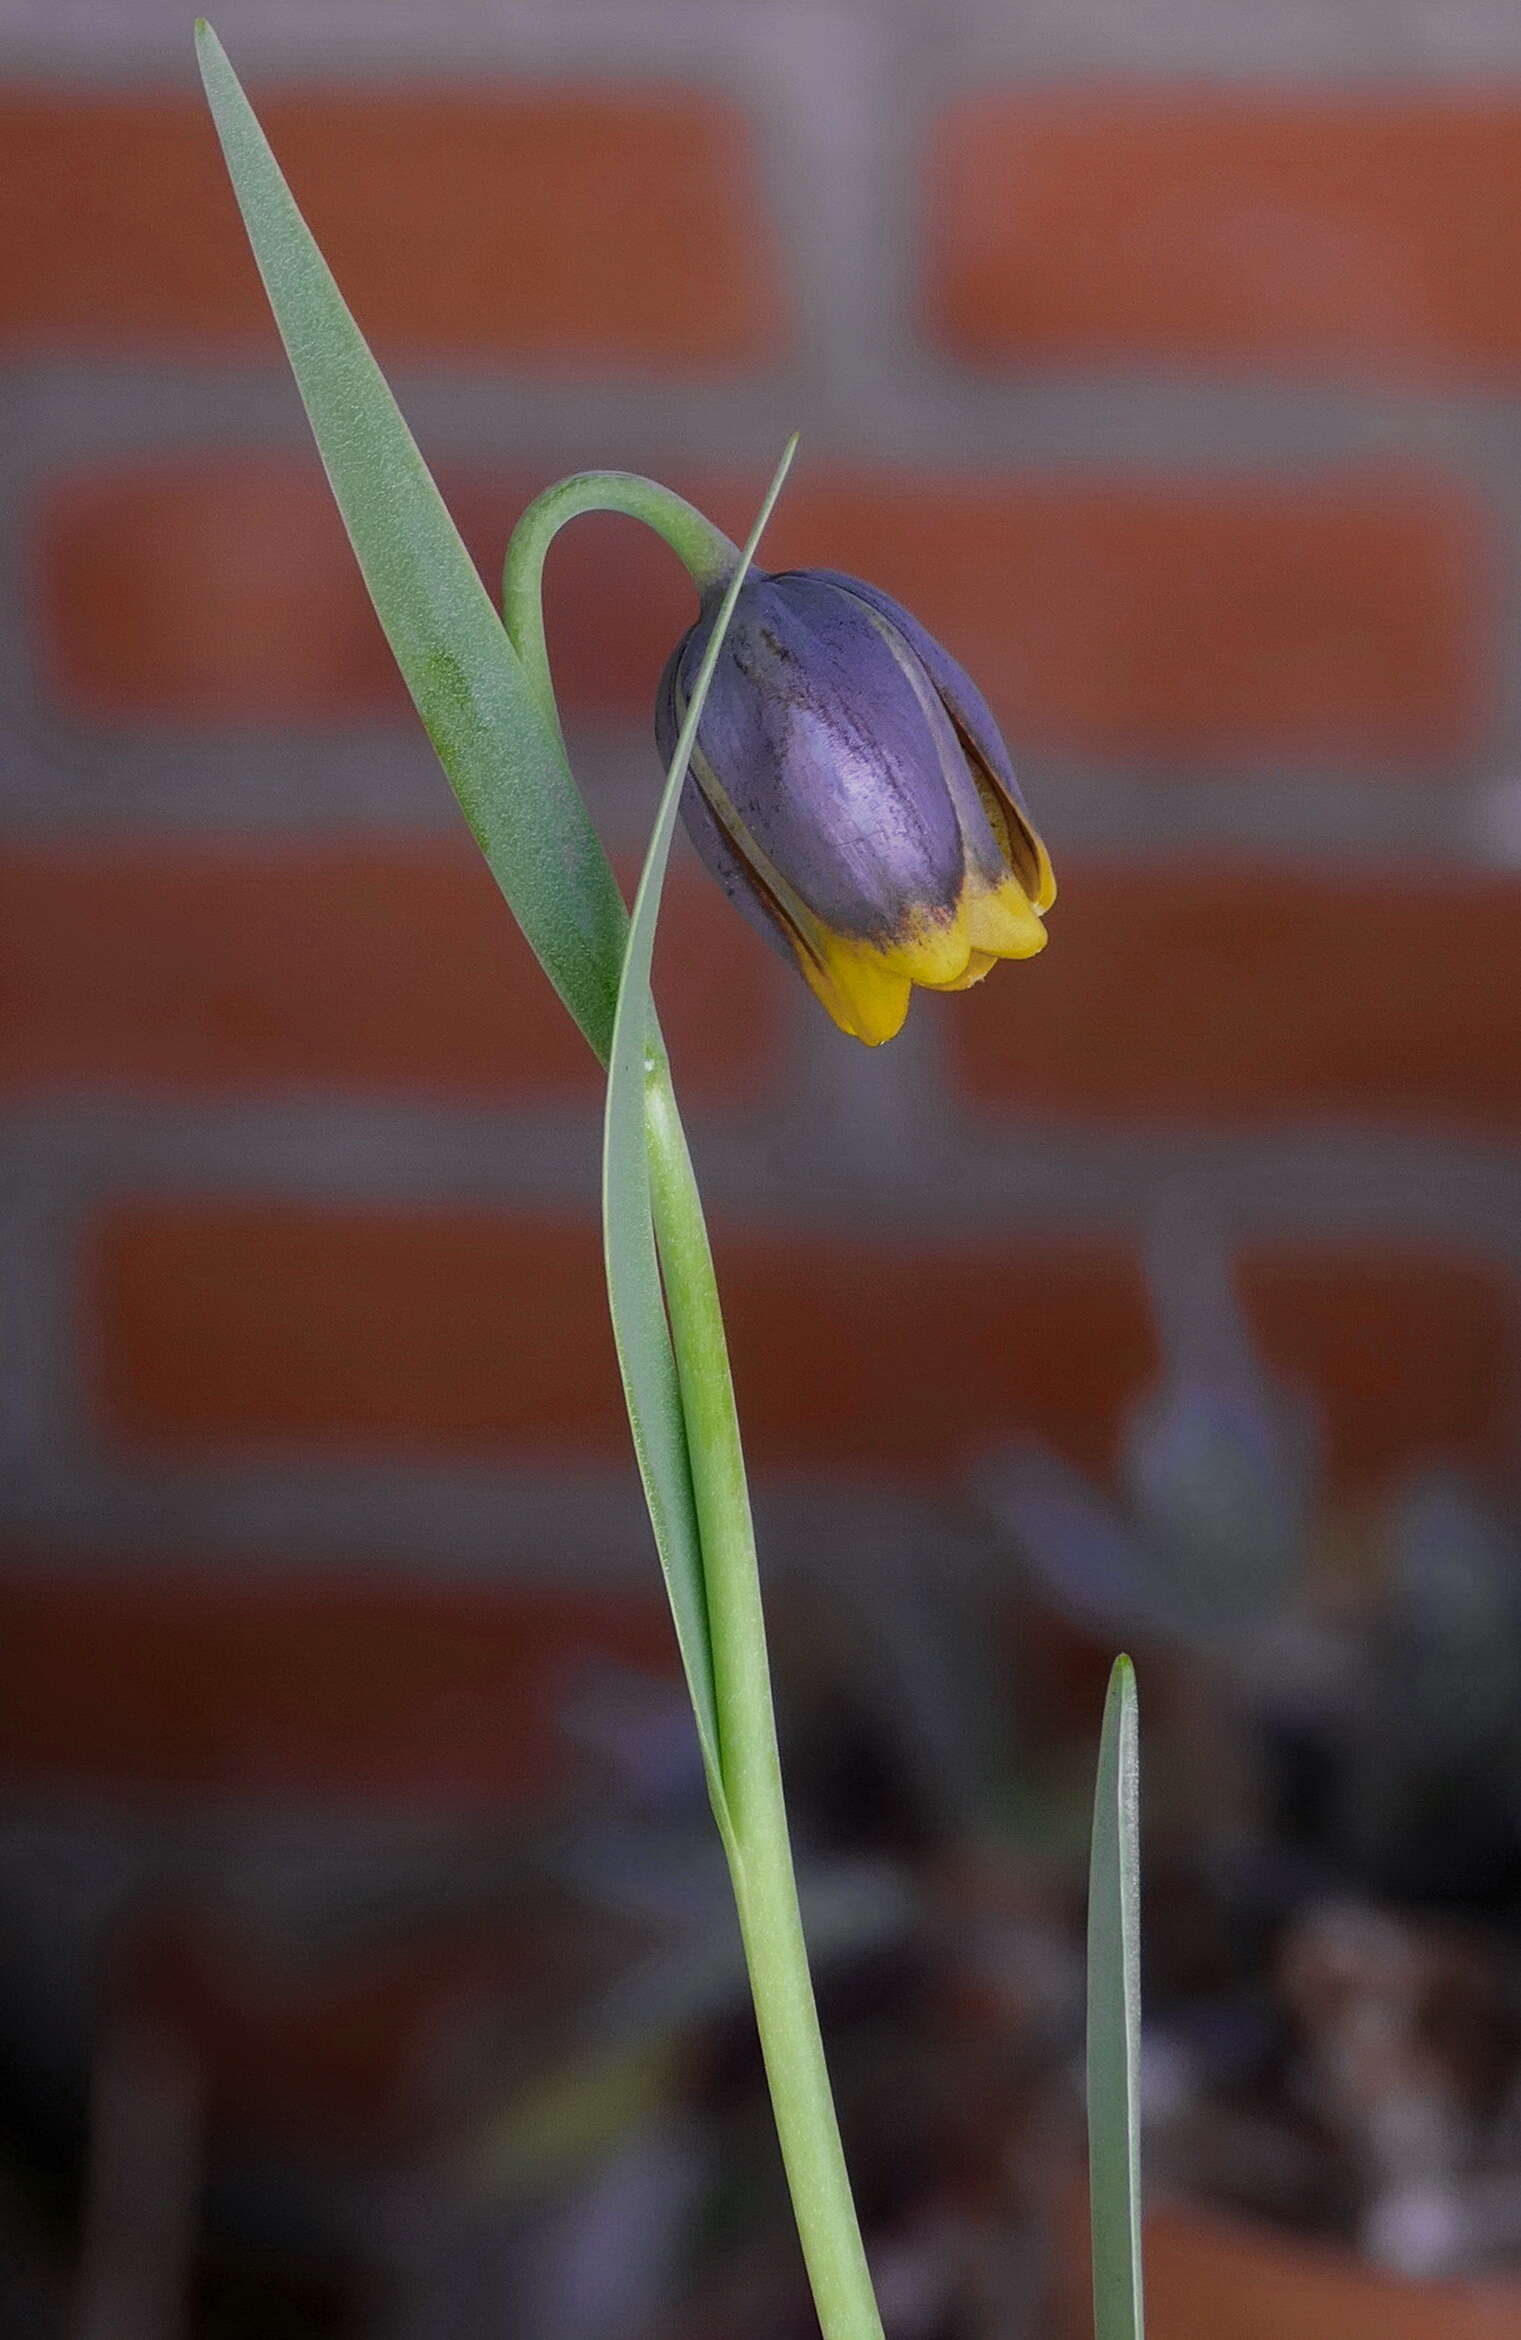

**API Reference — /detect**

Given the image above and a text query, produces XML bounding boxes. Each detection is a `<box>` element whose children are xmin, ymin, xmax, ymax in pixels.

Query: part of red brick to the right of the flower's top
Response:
<box><xmin>768</xmin><ymin>466</ymin><xmax>1493</xmax><ymax>763</ymax></box>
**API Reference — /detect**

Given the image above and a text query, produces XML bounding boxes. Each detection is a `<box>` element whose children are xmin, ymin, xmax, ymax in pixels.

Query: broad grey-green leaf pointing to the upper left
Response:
<box><xmin>197</xmin><ymin>23</ymin><xmax>625</xmax><ymax>1060</ymax></box>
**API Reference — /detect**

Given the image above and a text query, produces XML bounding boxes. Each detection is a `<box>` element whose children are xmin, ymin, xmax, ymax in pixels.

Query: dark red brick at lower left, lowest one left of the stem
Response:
<box><xmin>0</xmin><ymin>1556</ymin><xmax>674</xmax><ymax>1804</ymax></box>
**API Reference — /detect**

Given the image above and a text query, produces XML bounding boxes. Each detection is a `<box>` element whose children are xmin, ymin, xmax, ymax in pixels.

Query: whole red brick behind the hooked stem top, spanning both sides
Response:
<box><xmin>40</xmin><ymin>456</ymin><xmax>1495</xmax><ymax>765</ymax></box>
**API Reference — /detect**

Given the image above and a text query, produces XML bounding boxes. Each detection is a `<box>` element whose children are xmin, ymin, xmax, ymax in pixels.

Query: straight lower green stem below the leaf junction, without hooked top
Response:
<box><xmin>646</xmin><ymin>1067</ymin><xmax>882</xmax><ymax>2340</ymax></box>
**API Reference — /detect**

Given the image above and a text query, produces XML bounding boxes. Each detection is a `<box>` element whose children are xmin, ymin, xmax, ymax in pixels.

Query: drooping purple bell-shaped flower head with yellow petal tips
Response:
<box><xmin>655</xmin><ymin>569</ymin><xmax>1055</xmax><ymax>1046</ymax></box>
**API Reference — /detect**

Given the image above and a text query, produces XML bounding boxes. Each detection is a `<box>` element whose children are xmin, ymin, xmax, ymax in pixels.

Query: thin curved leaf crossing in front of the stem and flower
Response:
<box><xmin>601</xmin><ymin>438</ymin><xmax>798</xmax><ymax>1811</ymax></box>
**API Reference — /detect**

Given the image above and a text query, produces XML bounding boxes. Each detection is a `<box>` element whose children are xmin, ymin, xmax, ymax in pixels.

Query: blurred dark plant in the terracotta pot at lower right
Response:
<box><xmin>980</xmin><ymin>1193</ymin><xmax>1521</xmax><ymax>2272</ymax></box>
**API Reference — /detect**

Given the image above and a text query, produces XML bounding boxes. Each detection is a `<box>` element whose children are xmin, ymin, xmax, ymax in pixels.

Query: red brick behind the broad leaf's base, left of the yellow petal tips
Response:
<box><xmin>0</xmin><ymin>837</ymin><xmax>791</xmax><ymax>1104</ymax></box>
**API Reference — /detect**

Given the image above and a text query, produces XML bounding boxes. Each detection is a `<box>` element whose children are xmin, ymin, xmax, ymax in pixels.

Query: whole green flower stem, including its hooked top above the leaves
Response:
<box><xmin>503</xmin><ymin>470</ymin><xmax>882</xmax><ymax>2340</ymax></box>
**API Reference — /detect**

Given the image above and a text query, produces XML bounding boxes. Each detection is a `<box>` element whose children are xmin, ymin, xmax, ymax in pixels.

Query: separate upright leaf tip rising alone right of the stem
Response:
<box><xmin>1088</xmin><ymin>1657</ymin><xmax>1144</xmax><ymax>2340</ymax></box>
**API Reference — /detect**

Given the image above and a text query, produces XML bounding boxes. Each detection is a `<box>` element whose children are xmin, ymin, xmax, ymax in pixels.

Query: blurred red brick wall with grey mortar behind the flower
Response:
<box><xmin>0</xmin><ymin>0</ymin><xmax>1521</xmax><ymax>1795</ymax></box>
